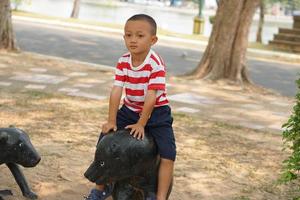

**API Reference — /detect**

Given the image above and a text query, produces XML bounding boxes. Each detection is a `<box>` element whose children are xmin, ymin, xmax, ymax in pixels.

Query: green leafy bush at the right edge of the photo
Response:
<box><xmin>281</xmin><ymin>74</ymin><xmax>300</xmax><ymax>183</ymax></box>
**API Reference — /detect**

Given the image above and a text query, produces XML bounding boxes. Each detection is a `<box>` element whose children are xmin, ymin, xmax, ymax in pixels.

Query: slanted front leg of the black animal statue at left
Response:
<box><xmin>6</xmin><ymin>163</ymin><xmax>38</xmax><ymax>199</ymax></box>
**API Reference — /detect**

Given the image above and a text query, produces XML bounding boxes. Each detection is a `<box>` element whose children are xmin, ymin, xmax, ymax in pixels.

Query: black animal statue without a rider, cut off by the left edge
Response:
<box><xmin>0</xmin><ymin>127</ymin><xmax>41</xmax><ymax>199</ymax></box>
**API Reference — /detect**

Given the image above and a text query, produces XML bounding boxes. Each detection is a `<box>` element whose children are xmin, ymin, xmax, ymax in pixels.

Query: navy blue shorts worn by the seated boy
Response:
<box><xmin>117</xmin><ymin>105</ymin><xmax>176</xmax><ymax>161</ymax></box>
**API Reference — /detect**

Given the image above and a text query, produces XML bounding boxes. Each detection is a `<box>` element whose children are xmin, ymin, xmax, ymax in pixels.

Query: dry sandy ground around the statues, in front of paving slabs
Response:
<box><xmin>0</xmin><ymin>51</ymin><xmax>300</xmax><ymax>200</ymax></box>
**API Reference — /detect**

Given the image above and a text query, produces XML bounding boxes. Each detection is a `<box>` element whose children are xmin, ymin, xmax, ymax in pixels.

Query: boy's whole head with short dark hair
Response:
<box><xmin>124</xmin><ymin>14</ymin><xmax>157</xmax><ymax>57</ymax></box>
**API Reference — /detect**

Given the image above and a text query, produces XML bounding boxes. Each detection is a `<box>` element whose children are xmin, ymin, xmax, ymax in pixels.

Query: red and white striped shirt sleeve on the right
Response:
<box><xmin>148</xmin><ymin>65</ymin><xmax>166</xmax><ymax>90</ymax></box>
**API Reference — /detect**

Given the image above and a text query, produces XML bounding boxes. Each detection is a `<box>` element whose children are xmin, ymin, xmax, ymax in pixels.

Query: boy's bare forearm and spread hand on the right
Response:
<box><xmin>125</xmin><ymin>90</ymin><xmax>156</xmax><ymax>139</ymax></box>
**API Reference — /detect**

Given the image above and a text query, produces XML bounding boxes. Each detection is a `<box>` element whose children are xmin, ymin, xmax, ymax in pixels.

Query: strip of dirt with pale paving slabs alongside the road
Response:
<box><xmin>0</xmin><ymin>53</ymin><xmax>293</xmax><ymax>133</ymax></box>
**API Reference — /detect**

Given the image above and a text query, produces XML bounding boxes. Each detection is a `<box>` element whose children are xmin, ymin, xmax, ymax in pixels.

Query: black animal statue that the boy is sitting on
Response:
<box><xmin>84</xmin><ymin>130</ymin><xmax>172</xmax><ymax>200</ymax></box>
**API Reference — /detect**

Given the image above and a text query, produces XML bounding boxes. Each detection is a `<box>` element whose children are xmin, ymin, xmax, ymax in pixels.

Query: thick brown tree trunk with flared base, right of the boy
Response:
<box><xmin>191</xmin><ymin>0</ymin><xmax>259</xmax><ymax>84</ymax></box>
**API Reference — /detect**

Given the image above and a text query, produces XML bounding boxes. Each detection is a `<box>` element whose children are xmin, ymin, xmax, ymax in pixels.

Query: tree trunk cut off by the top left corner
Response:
<box><xmin>0</xmin><ymin>0</ymin><xmax>18</xmax><ymax>50</ymax></box>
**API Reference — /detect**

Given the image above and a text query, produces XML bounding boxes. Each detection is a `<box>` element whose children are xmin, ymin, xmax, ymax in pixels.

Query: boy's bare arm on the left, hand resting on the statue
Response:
<box><xmin>102</xmin><ymin>85</ymin><xmax>123</xmax><ymax>133</ymax></box>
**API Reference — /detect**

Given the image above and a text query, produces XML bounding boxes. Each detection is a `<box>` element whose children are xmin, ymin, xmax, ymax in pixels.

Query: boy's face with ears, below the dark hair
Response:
<box><xmin>124</xmin><ymin>20</ymin><xmax>157</xmax><ymax>55</ymax></box>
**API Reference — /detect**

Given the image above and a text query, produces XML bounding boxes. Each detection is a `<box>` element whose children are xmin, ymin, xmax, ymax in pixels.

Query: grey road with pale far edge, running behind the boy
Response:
<box><xmin>14</xmin><ymin>17</ymin><xmax>300</xmax><ymax>96</ymax></box>
